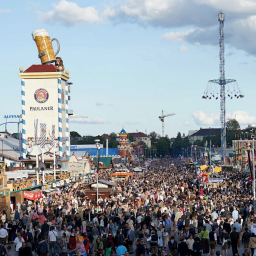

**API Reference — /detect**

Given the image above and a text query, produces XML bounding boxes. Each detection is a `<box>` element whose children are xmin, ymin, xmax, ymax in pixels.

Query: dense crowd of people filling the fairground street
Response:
<box><xmin>0</xmin><ymin>159</ymin><xmax>256</xmax><ymax>256</ymax></box>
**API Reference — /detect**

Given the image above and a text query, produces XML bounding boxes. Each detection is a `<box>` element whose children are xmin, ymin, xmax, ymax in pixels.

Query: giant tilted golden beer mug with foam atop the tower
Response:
<box><xmin>32</xmin><ymin>28</ymin><xmax>60</xmax><ymax>64</ymax></box>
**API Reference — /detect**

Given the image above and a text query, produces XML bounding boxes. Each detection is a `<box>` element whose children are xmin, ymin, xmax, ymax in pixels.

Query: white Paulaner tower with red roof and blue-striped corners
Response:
<box><xmin>20</xmin><ymin>64</ymin><xmax>70</xmax><ymax>159</ymax></box>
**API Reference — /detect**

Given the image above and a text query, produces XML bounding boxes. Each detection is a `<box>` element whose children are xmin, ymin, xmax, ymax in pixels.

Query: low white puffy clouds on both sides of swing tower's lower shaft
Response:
<box><xmin>192</xmin><ymin>110</ymin><xmax>256</xmax><ymax>126</ymax></box>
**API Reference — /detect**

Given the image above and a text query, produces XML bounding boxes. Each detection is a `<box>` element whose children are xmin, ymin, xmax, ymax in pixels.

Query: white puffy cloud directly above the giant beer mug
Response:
<box><xmin>38</xmin><ymin>0</ymin><xmax>100</xmax><ymax>26</ymax></box>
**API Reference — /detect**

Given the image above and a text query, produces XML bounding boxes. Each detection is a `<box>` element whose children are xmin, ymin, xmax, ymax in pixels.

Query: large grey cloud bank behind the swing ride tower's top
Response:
<box><xmin>105</xmin><ymin>0</ymin><xmax>256</xmax><ymax>54</ymax></box>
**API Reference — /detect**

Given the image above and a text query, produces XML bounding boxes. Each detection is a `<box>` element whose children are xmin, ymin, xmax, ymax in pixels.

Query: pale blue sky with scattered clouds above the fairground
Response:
<box><xmin>0</xmin><ymin>0</ymin><xmax>256</xmax><ymax>137</ymax></box>
